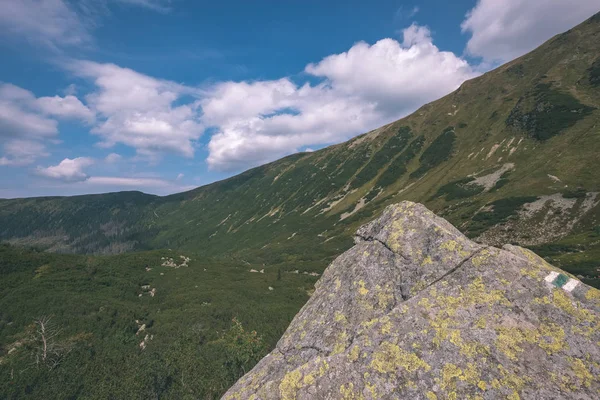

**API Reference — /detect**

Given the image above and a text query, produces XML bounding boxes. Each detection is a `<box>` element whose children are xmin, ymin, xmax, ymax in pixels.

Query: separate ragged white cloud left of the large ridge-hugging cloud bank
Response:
<box><xmin>68</xmin><ymin>61</ymin><xmax>204</xmax><ymax>157</ymax></box>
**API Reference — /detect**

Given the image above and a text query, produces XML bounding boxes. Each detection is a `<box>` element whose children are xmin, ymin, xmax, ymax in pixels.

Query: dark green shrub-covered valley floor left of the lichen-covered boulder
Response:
<box><xmin>0</xmin><ymin>245</ymin><xmax>318</xmax><ymax>399</ymax></box>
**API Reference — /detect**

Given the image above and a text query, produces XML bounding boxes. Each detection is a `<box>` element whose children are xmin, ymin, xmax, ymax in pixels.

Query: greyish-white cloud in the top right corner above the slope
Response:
<box><xmin>461</xmin><ymin>0</ymin><xmax>600</xmax><ymax>63</ymax></box>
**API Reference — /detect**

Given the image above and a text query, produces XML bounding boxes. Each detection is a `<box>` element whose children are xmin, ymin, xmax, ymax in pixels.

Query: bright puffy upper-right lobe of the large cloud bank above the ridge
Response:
<box><xmin>306</xmin><ymin>24</ymin><xmax>476</xmax><ymax>117</ymax></box>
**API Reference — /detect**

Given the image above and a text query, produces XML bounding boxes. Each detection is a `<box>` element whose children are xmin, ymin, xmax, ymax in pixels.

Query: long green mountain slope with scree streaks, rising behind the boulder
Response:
<box><xmin>0</xmin><ymin>14</ymin><xmax>600</xmax><ymax>283</ymax></box>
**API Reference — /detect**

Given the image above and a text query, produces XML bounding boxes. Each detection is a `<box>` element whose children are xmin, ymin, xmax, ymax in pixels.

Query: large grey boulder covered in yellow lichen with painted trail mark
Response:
<box><xmin>224</xmin><ymin>202</ymin><xmax>600</xmax><ymax>400</ymax></box>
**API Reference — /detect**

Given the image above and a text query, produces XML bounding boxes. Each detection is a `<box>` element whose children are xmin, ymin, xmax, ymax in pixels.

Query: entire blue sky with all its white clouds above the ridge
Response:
<box><xmin>0</xmin><ymin>0</ymin><xmax>600</xmax><ymax>197</ymax></box>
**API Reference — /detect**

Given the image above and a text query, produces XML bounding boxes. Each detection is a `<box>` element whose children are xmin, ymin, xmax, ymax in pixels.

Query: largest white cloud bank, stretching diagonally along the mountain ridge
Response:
<box><xmin>204</xmin><ymin>24</ymin><xmax>476</xmax><ymax>171</ymax></box>
